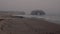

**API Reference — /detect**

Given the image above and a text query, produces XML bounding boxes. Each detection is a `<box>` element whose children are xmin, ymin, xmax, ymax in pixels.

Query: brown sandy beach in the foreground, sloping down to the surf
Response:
<box><xmin>0</xmin><ymin>15</ymin><xmax>60</xmax><ymax>34</ymax></box>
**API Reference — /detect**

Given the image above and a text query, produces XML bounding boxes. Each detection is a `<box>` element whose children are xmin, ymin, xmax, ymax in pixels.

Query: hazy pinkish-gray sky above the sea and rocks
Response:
<box><xmin>0</xmin><ymin>0</ymin><xmax>60</xmax><ymax>14</ymax></box>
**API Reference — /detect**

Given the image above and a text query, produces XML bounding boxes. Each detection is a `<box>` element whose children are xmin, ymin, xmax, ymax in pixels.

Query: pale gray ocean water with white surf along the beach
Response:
<box><xmin>14</xmin><ymin>15</ymin><xmax>60</xmax><ymax>24</ymax></box>
